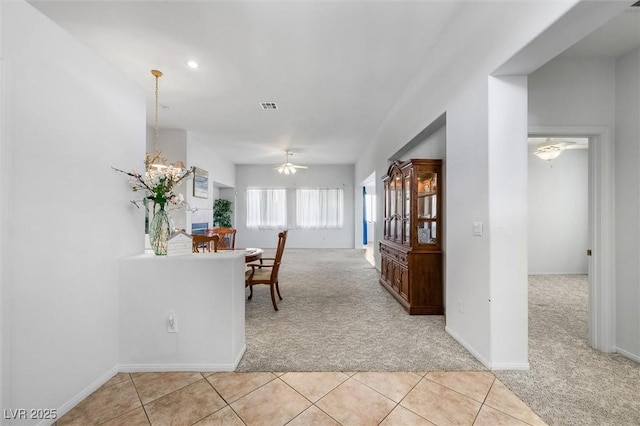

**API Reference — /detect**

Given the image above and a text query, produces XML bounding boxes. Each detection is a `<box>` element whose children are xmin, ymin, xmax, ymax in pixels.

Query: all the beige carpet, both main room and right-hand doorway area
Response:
<box><xmin>238</xmin><ymin>249</ymin><xmax>640</xmax><ymax>425</ymax></box>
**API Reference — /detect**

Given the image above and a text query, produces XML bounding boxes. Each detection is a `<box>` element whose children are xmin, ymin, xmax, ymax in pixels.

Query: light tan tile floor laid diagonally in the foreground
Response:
<box><xmin>57</xmin><ymin>372</ymin><xmax>545</xmax><ymax>426</ymax></box>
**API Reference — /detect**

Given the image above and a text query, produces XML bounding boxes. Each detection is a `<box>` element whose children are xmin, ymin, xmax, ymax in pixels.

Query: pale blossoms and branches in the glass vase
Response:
<box><xmin>112</xmin><ymin>166</ymin><xmax>194</xmax><ymax>207</ymax></box>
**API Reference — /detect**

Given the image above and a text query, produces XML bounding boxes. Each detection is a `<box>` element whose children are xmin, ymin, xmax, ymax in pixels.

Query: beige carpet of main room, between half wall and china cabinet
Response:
<box><xmin>238</xmin><ymin>249</ymin><xmax>486</xmax><ymax>371</ymax></box>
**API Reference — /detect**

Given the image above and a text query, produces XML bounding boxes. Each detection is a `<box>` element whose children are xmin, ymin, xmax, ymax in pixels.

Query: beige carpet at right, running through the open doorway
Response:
<box><xmin>494</xmin><ymin>275</ymin><xmax>640</xmax><ymax>425</ymax></box>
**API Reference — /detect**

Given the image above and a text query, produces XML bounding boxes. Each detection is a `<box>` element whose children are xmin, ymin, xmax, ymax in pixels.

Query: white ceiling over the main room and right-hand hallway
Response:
<box><xmin>30</xmin><ymin>0</ymin><xmax>640</xmax><ymax>164</ymax></box>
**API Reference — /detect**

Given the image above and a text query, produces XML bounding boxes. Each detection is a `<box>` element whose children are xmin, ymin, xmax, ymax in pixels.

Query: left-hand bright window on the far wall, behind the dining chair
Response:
<box><xmin>247</xmin><ymin>189</ymin><xmax>287</xmax><ymax>229</ymax></box>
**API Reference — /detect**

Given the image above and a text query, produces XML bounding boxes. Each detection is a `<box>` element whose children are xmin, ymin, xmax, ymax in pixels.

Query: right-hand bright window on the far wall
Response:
<box><xmin>296</xmin><ymin>189</ymin><xmax>344</xmax><ymax>228</ymax></box>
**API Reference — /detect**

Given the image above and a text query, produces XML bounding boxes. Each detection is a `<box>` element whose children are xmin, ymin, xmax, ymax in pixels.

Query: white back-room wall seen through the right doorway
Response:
<box><xmin>528</xmin><ymin>149</ymin><xmax>589</xmax><ymax>274</ymax></box>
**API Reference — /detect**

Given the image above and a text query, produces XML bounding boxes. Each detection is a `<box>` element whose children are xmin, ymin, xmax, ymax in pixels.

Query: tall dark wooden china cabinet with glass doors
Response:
<box><xmin>380</xmin><ymin>159</ymin><xmax>444</xmax><ymax>315</ymax></box>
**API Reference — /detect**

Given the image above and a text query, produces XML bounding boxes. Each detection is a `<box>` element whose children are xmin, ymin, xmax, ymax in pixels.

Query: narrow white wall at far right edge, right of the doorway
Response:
<box><xmin>615</xmin><ymin>46</ymin><xmax>640</xmax><ymax>362</ymax></box>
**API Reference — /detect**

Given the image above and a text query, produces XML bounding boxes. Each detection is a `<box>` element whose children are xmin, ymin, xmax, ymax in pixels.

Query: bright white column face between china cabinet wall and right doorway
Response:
<box><xmin>488</xmin><ymin>76</ymin><xmax>529</xmax><ymax>370</ymax></box>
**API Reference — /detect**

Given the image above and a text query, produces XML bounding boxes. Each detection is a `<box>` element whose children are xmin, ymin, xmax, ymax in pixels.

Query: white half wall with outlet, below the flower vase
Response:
<box><xmin>119</xmin><ymin>251</ymin><xmax>246</xmax><ymax>372</ymax></box>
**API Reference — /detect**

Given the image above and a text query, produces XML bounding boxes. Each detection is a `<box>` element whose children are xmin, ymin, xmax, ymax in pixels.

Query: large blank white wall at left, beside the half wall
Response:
<box><xmin>0</xmin><ymin>1</ymin><xmax>145</xmax><ymax>420</ymax></box>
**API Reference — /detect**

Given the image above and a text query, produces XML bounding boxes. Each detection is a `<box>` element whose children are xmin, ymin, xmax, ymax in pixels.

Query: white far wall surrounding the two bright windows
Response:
<box><xmin>235</xmin><ymin>165</ymin><xmax>362</xmax><ymax>248</ymax></box>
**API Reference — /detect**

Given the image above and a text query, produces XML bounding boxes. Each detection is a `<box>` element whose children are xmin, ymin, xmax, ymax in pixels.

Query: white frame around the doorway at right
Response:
<box><xmin>529</xmin><ymin>126</ymin><xmax>616</xmax><ymax>353</ymax></box>
